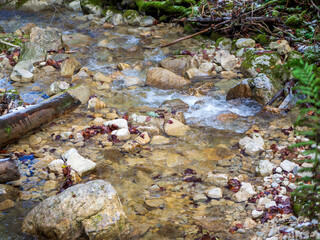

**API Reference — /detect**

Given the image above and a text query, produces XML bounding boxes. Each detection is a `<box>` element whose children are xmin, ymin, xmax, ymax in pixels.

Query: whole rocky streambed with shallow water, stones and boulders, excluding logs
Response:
<box><xmin>0</xmin><ymin>7</ymin><xmax>315</xmax><ymax>240</ymax></box>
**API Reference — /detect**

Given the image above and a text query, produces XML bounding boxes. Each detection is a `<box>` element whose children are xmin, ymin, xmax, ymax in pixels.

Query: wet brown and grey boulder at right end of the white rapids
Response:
<box><xmin>227</xmin><ymin>73</ymin><xmax>281</xmax><ymax>105</ymax></box>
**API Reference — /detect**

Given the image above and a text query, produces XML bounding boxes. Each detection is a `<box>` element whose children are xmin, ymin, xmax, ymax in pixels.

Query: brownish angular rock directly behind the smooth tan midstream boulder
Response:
<box><xmin>160</xmin><ymin>56</ymin><xmax>191</xmax><ymax>76</ymax></box>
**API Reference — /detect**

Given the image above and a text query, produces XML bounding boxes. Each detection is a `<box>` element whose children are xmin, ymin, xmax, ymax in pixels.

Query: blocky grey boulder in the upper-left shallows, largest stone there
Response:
<box><xmin>30</xmin><ymin>27</ymin><xmax>63</xmax><ymax>51</ymax></box>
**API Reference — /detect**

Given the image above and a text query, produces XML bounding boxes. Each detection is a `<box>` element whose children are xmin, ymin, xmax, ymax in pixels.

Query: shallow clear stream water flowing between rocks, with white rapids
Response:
<box><xmin>0</xmin><ymin>7</ymin><xmax>280</xmax><ymax>239</ymax></box>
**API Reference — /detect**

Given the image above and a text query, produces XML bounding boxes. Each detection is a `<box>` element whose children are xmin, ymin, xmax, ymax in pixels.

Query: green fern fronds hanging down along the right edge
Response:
<box><xmin>290</xmin><ymin>60</ymin><xmax>320</xmax><ymax>230</ymax></box>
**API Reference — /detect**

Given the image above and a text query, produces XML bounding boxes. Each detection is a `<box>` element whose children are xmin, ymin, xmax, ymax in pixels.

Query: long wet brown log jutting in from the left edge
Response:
<box><xmin>0</xmin><ymin>92</ymin><xmax>81</xmax><ymax>147</ymax></box>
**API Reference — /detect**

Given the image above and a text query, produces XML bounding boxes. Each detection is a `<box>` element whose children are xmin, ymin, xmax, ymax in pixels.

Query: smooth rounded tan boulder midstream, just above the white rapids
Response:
<box><xmin>146</xmin><ymin>67</ymin><xmax>191</xmax><ymax>89</ymax></box>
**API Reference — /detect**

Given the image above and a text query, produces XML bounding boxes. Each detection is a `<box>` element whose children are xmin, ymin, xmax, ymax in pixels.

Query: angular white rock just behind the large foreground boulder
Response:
<box><xmin>63</xmin><ymin>148</ymin><xmax>96</xmax><ymax>177</ymax></box>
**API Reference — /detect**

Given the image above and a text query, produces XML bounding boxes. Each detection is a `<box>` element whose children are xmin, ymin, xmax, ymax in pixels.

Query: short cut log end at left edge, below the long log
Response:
<box><xmin>0</xmin><ymin>158</ymin><xmax>20</xmax><ymax>184</ymax></box>
